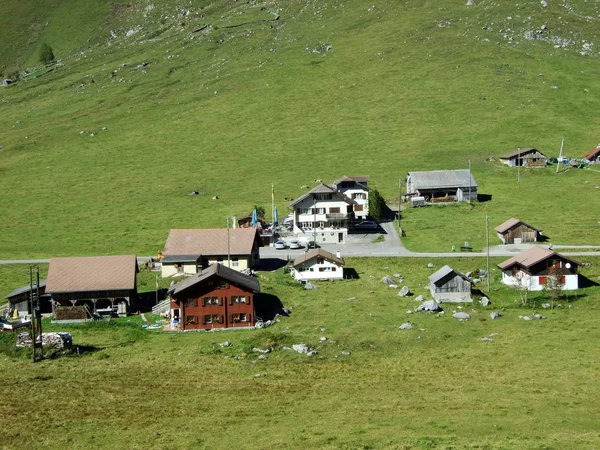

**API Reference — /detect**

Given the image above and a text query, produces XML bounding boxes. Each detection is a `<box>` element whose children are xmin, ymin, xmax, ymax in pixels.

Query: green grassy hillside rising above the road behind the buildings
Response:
<box><xmin>0</xmin><ymin>1</ymin><xmax>600</xmax><ymax>257</ymax></box>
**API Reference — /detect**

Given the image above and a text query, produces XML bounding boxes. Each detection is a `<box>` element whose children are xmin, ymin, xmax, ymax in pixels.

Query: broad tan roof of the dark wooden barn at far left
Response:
<box><xmin>46</xmin><ymin>255</ymin><xmax>138</xmax><ymax>294</ymax></box>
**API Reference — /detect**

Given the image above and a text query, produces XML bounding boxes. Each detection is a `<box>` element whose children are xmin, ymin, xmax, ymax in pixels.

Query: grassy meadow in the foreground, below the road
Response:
<box><xmin>0</xmin><ymin>258</ymin><xmax>600</xmax><ymax>449</ymax></box>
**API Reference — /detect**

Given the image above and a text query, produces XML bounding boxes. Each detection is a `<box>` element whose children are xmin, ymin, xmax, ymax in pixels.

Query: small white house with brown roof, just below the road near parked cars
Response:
<box><xmin>290</xmin><ymin>248</ymin><xmax>344</xmax><ymax>281</ymax></box>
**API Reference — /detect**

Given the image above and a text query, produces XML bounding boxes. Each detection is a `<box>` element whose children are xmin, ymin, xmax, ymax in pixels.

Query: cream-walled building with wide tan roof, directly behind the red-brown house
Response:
<box><xmin>161</xmin><ymin>228</ymin><xmax>262</xmax><ymax>278</ymax></box>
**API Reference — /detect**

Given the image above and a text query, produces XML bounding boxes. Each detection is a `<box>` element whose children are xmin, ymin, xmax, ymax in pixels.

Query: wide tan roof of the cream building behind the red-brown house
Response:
<box><xmin>163</xmin><ymin>228</ymin><xmax>259</xmax><ymax>257</ymax></box>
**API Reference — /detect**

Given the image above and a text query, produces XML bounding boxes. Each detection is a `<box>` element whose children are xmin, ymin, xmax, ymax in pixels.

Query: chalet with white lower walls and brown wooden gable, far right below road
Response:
<box><xmin>498</xmin><ymin>246</ymin><xmax>579</xmax><ymax>291</ymax></box>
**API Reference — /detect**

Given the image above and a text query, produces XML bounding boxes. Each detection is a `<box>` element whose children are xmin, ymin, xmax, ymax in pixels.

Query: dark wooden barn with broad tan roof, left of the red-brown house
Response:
<box><xmin>46</xmin><ymin>255</ymin><xmax>139</xmax><ymax>314</ymax></box>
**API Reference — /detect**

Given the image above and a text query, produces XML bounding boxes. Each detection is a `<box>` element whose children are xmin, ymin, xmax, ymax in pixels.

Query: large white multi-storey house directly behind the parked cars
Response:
<box><xmin>289</xmin><ymin>184</ymin><xmax>356</xmax><ymax>243</ymax></box>
